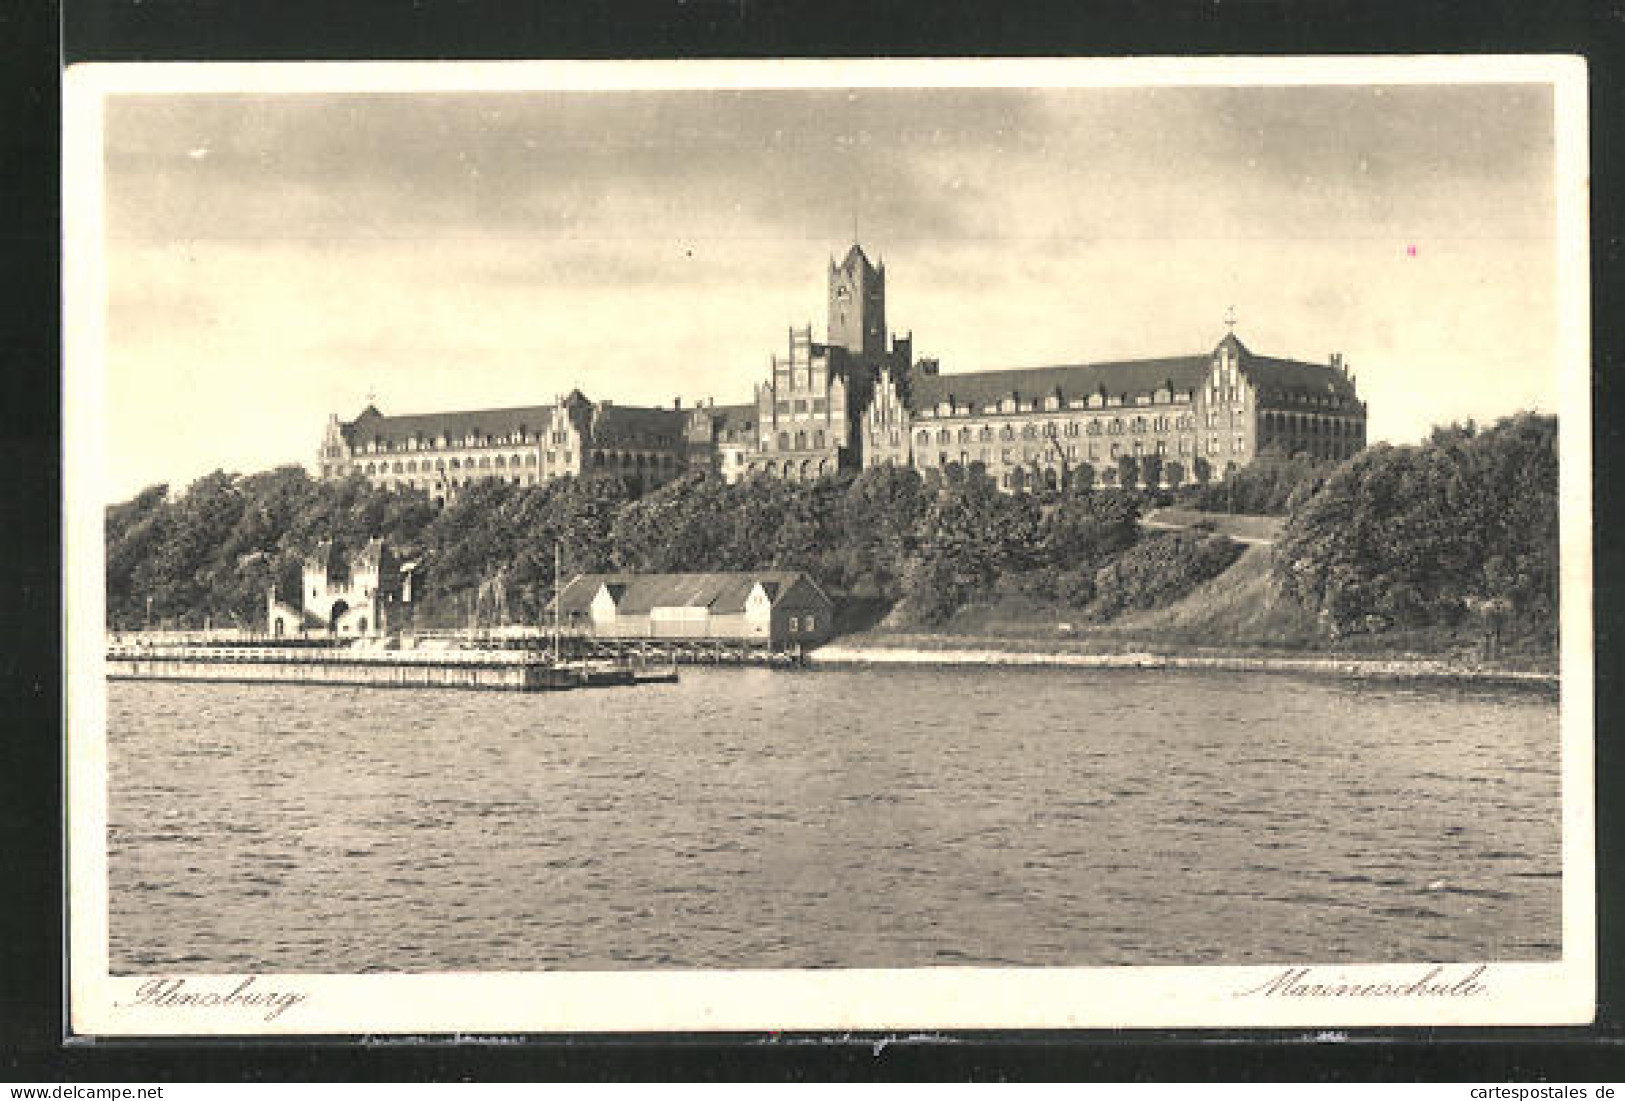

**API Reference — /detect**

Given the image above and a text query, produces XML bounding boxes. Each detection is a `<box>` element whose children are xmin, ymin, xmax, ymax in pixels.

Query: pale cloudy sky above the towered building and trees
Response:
<box><xmin>104</xmin><ymin>84</ymin><xmax>1558</xmax><ymax>500</ymax></box>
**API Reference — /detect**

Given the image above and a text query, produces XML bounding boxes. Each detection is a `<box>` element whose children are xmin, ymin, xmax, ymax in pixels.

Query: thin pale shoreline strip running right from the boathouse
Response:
<box><xmin>806</xmin><ymin>643</ymin><xmax>1558</xmax><ymax>689</ymax></box>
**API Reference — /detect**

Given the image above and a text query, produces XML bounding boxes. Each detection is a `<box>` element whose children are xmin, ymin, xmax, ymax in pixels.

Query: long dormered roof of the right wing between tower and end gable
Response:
<box><xmin>908</xmin><ymin>356</ymin><xmax>1212</xmax><ymax>416</ymax></box>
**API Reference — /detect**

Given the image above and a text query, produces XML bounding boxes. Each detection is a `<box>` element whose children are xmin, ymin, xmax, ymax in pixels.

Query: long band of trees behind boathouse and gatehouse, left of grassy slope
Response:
<box><xmin>107</xmin><ymin>468</ymin><xmax>1139</xmax><ymax>628</ymax></box>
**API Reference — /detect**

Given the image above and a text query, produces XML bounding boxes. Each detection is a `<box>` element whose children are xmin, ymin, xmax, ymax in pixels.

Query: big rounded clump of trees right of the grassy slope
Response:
<box><xmin>1276</xmin><ymin>414</ymin><xmax>1558</xmax><ymax>648</ymax></box>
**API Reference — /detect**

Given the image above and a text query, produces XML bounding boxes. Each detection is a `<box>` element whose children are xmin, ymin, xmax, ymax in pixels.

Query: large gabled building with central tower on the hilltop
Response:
<box><xmin>319</xmin><ymin>244</ymin><xmax>1367</xmax><ymax>502</ymax></box>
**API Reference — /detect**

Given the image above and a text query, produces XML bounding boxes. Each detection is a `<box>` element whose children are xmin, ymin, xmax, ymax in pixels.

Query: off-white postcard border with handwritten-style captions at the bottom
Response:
<box><xmin>62</xmin><ymin>57</ymin><xmax>1596</xmax><ymax>1036</ymax></box>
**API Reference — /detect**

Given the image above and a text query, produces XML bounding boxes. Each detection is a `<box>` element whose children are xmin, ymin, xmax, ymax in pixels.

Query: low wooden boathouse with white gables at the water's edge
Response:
<box><xmin>559</xmin><ymin>570</ymin><xmax>835</xmax><ymax>650</ymax></box>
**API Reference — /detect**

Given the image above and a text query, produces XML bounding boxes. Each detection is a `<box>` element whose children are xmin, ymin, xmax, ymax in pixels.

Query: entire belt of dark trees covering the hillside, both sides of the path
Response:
<box><xmin>106</xmin><ymin>414</ymin><xmax>1557</xmax><ymax>656</ymax></box>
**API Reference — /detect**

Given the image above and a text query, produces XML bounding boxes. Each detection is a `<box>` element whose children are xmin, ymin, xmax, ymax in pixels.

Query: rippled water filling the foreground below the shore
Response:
<box><xmin>109</xmin><ymin>669</ymin><xmax>1560</xmax><ymax>974</ymax></box>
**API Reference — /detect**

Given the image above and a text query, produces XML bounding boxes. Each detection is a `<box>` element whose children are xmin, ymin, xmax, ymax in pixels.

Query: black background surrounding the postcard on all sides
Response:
<box><xmin>0</xmin><ymin>0</ymin><xmax>1625</xmax><ymax>1083</ymax></box>
